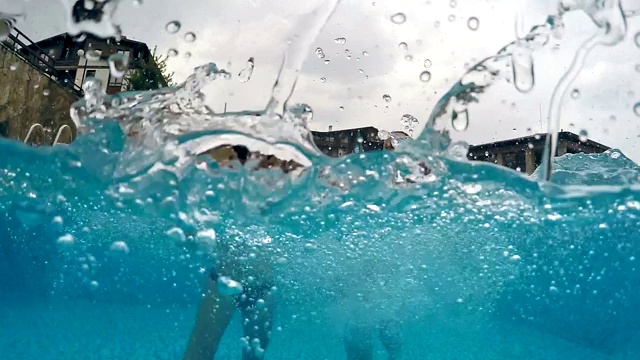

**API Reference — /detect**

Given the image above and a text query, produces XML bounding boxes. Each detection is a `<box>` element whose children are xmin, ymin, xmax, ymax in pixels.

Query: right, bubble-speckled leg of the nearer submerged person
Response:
<box><xmin>240</xmin><ymin>286</ymin><xmax>275</xmax><ymax>360</ymax></box>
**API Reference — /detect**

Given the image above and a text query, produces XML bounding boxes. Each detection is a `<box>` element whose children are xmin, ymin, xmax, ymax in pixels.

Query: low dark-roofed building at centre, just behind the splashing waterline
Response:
<box><xmin>312</xmin><ymin>126</ymin><xmax>384</xmax><ymax>157</ymax></box>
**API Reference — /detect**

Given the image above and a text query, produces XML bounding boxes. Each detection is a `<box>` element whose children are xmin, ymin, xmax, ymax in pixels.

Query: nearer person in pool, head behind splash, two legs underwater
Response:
<box><xmin>184</xmin><ymin>145</ymin><xmax>304</xmax><ymax>360</ymax></box>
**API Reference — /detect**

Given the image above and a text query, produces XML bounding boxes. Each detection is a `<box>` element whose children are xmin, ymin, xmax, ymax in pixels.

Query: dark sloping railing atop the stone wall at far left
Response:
<box><xmin>1</xmin><ymin>28</ymin><xmax>83</xmax><ymax>97</ymax></box>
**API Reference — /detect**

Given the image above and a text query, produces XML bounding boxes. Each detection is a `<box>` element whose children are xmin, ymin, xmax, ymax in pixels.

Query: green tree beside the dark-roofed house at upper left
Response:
<box><xmin>126</xmin><ymin>47</ymin><xmax>174</xmax><ymax>91</ymax></box>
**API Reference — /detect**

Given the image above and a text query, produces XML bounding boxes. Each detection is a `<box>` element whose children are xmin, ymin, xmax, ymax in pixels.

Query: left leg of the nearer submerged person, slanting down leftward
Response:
<box><xmin>183</xmin><ymin>279</ymin><xmax>236</xmax><ymax>360</ymax></box>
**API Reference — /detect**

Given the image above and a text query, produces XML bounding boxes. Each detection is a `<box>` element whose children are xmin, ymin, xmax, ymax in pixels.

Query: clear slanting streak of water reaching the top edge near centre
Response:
<box><xmin>265</xmin><ymin>0</ymin><xmax>340</xmax><ymax>115</ymax></box>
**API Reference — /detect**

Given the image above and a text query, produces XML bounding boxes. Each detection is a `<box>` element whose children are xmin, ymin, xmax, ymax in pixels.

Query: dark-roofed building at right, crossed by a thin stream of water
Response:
<box><xmin>467</xmin><ymin>131</ymin><xmax>609</xmax><ymax>175</ymax></box>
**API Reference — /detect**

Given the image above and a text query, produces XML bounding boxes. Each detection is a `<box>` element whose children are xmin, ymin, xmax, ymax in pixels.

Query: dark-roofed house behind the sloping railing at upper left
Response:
<box><xmin>22</xmin><ymin>33</ymin><xmax>160</xmax><ymax>94</ymax></box>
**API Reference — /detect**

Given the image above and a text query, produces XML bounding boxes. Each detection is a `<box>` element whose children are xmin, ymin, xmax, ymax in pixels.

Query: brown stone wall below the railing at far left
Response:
<box><xmin>0</xmin><ymin>45</ymin><xmax>78</xmax><ymax>145</ymax></box>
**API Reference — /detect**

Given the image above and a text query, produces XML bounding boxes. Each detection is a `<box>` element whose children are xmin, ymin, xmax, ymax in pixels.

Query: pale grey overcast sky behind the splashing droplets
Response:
<box><xmin>0</xmin><ymin>0</ymin><xmax>640</xmax><ymax>162</ymax></box>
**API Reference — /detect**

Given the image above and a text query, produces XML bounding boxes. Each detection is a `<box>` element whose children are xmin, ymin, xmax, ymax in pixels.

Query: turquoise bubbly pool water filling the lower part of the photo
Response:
<box><xmin>0</xmin><ymin>116</ymin><xmax>640</xmax><ymax>359</ymax></box>
